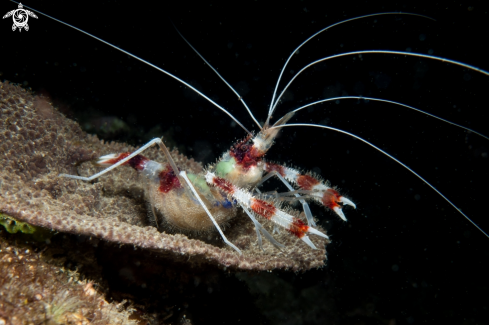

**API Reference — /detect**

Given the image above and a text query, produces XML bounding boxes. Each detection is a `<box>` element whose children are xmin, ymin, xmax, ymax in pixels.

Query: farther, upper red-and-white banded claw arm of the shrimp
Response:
<box><xmin>264</xmin><ymin>162</ymin><xmax>356</xmax><ymax>221</ymax></box>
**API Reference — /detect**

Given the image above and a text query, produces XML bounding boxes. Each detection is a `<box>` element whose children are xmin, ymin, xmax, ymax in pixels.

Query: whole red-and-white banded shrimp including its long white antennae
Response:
<box><xmin>31</xmin><ymin>8</ymin><xmax>489</xmax><ymax>254</ymax></box>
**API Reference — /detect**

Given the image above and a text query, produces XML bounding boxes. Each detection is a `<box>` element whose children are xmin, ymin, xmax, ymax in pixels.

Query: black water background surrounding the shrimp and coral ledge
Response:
<box><xmin>0</xmin><ymin>1</ymin><xmax>489</xmax><ymax>324</ymax></box>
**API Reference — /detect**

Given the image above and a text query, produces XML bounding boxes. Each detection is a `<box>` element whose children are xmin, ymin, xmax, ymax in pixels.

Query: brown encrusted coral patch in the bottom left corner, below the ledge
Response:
<box><xmin>0</xmin><ymin>236</ymin><xmax>137</xmax><ymax>325</ymax></box>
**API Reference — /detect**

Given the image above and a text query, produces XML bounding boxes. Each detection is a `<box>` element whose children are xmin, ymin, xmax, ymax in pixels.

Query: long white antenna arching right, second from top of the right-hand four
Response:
<box><xmin>270</xmin><ymin>50</ymin><xmax>489</xmax><ymax>120</ymax></box>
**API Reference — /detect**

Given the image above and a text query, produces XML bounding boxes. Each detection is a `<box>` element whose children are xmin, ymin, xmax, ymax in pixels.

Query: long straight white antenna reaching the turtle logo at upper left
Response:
<box><xmin>15</xmin><ymin>0</ymin><xmax>251</xmax><ymax>135</ymax></box>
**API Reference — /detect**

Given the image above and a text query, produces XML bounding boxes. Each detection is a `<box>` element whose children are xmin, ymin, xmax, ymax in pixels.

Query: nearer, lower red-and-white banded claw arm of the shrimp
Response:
<box><xmin>205</xmin><ymin>172</ymin><xmax>329</xmax><ymax>249</ymax></box>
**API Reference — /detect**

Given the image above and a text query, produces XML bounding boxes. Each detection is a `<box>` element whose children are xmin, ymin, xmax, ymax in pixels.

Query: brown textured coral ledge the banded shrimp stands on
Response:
<box><xmin>0</xmin><ymin>82</ymin><xmax>327</xmax><ymax>271</ymax></box>
